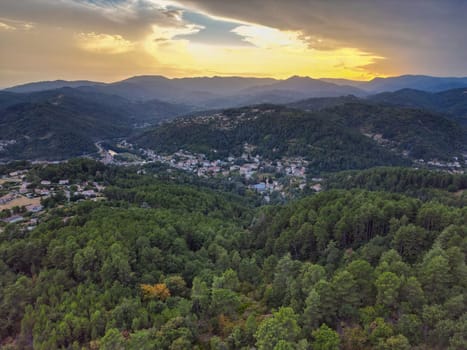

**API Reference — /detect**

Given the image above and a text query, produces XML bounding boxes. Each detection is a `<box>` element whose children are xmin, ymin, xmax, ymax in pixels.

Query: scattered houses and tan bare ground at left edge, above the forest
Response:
<box><xmin>0</xmin><ymin>169</ymin><xmax>104</xmax><ymax>231</ymax></box>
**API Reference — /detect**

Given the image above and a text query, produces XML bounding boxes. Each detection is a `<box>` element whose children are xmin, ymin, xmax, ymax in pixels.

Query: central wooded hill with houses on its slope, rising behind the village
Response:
<box><xmin>133</xmin><ymin>105</ymin><xmax>409</xmax><ymax>172</ymax></box>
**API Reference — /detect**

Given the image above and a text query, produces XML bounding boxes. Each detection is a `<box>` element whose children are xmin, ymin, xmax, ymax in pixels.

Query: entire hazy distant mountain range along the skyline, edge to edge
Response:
<box><xmin>4</xmin><ymin>75</ymin><xmax>467</xmax><ymax>109</ymax></box>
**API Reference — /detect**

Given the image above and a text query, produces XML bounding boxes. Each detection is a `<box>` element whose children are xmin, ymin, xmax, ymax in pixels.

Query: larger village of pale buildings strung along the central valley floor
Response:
<box><xmin>100</xmin><ymin>140</ymin><xmax>323</xmax><ymax>202</ymax></box>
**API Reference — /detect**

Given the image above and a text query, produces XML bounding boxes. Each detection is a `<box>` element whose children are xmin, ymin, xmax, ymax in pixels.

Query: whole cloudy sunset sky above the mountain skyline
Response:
<box><xmin>0</xmin><ymin>0</ymin><xmax>467</xmax><ymax>87</ymax></box>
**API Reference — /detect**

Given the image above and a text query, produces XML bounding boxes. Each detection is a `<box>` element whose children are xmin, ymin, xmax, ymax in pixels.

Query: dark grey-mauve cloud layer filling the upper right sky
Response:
<box><xmin>184</xmin><ymin>0</ymin><xmax>467</xmax><ymax>75</ymax></box>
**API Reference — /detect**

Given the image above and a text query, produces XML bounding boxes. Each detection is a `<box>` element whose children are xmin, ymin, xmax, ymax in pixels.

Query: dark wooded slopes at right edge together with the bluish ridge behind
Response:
<box><xmin>290</xmin><ymin>100</ymin><xmax>467</xmax><ymax>159</ymax></box>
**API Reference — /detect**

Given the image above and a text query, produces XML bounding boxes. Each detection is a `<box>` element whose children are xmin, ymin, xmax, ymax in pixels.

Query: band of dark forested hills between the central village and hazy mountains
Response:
<box><xmin>0</xmin><ymin>85</ymin><xmax>467</xmax><ymax>165</ymax></box>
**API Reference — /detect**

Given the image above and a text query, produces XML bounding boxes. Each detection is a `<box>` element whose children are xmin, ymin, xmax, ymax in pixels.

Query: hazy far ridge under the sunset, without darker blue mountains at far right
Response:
<box><xmin>5</xmin><ymin>75</ymin><xmax>366</xmax><ymax>109</ymax></box>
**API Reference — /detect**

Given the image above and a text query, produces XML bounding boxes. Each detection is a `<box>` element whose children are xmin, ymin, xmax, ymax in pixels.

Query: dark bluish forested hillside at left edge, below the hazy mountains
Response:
<box><xmin>0</xmin><ymin>88</ymin><xmax>190</xmax><ymax>160</ymax></box>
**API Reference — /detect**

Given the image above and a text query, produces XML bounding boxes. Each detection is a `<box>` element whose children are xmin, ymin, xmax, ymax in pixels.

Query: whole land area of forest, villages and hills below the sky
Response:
<box><xmin>0</xmin><ymin>77</ymin><xmax>467</xmax><ymax>350</ymax></box>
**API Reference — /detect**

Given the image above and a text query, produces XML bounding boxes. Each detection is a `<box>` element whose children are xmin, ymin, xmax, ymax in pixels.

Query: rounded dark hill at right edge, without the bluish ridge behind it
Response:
<box><xmin>321</xmin><ymin>103</ymin><xmax>467</xmax><ymax>160</ymax></box>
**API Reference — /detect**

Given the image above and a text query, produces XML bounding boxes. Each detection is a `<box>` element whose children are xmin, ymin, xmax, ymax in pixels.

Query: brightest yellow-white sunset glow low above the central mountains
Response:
<box><xmin>138</xmin><ymin>25</ymin><xmax>383</xmax><ymax>80</ymax></box>
